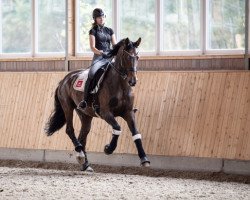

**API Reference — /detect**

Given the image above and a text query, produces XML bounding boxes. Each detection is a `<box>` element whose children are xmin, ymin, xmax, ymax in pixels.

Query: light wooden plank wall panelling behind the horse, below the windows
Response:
<box><xmin>0</xmin><ymin>71</ymin><xmax>250</xmax><ymax>160</ymax></box>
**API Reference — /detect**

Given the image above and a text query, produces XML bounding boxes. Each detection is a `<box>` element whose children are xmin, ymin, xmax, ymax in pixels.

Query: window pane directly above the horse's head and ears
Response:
<box><xmin>119</xmin><ymin>0</ymin><xmax>156</xmax><ymax>52</ymax></box>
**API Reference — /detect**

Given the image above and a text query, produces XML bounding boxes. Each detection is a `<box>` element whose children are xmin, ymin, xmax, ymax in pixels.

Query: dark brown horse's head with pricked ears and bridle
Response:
<box><xmin>117</xmin><ymin>38</ymin><xmax>141</xmax><ymax>86</ymax></box>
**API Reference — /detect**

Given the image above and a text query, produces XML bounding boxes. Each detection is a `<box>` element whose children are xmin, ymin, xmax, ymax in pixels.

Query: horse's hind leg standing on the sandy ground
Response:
<box><xmin>77</xmin><ymin>111</ymin><xmax>93</xmax><ymax>171</ymax></box>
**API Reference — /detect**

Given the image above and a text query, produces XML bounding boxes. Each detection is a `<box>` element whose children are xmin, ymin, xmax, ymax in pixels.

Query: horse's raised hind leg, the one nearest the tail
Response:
<box><xmin>60</xmin><ymin>99</ymin><xmax>83</xmax><ymax>152</ymax></box>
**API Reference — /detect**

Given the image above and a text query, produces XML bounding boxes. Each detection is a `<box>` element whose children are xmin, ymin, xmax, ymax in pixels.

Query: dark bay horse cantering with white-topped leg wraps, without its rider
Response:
<box><xmin>45</xmin><ymin>38</ymin><xmax>150</xmax><ymax>170</ymax></box>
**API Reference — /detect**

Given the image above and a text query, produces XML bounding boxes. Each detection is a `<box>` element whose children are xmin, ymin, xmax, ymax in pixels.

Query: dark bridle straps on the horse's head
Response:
<box><xmin>110</xmin><ymin>49</ymin><xmax>139</xmax><ymax>80</ymax></box>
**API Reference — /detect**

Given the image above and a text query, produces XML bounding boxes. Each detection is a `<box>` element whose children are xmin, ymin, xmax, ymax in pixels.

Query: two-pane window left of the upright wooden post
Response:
<box><xmin>0</xmin><ymin>0</ymin><xmax>66</xmax><ymax>55</ymax></box>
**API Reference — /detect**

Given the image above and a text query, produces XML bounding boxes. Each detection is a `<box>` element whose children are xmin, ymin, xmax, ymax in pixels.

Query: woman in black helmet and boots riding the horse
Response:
<box><xmin>78</xmin><ymin>8</ymin><xmax>116</xmax><ymax>109</ymax></box>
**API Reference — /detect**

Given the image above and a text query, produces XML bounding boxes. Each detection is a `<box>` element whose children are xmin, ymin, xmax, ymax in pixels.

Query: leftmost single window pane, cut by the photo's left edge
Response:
<box><xmin>0</xmin><ymin>0</ymin><xmax>32</xmax><ymax>53</ymax></box>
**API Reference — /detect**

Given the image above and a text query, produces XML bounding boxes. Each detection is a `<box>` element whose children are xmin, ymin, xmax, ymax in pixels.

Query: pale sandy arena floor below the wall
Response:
<box><xmin>0</xmin><ymin>161</ymin><xmax>250</xmax><ymax>200</ymax></box>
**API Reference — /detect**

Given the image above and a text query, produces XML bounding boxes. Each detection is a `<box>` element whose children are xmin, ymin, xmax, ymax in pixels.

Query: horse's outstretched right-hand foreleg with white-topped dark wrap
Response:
<box><xmin>123</xmin><ymin>111</ymin><xmax>150</xmax><ymax>167</ymax></box>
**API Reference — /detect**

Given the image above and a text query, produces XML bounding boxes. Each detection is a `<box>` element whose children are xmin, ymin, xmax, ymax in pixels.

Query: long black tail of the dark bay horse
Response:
<box><xmin>45</xmin><ymin>88</ymin><xmax>66</xmax><ymax>136</ymax></box>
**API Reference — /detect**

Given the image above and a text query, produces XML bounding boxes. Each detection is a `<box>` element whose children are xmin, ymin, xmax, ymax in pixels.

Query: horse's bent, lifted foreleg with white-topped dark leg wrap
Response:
<box><xmin>103</xmin><ymin>113</ymin><xmax>121</xmax><ymax>154</ymax></box>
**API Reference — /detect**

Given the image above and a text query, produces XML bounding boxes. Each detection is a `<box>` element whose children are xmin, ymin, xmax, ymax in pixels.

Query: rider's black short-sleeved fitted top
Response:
<box><xmin>89</xmin><ymin>25</ymin><xmax>114</xmax><ymax>52</ymax></box>
